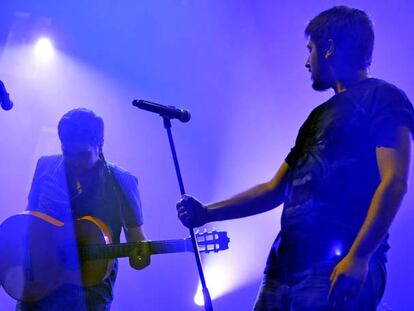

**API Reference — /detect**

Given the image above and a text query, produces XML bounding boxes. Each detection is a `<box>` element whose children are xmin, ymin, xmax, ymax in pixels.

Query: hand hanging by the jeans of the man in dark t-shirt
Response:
<box><xmin>329</xmin><ymin>254</ymin><xmax>369</xmax><ymax>307</ymax></box>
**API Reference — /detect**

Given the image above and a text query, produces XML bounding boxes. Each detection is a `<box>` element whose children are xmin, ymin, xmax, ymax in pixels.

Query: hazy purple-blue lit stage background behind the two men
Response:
<box><xmin>0</xmin><ymin>0</ymin><xmax>414</xmax><ymax>311</ymax></box>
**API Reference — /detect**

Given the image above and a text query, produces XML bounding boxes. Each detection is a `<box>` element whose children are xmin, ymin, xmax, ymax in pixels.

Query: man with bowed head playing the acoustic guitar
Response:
<box><xmin>17</xmin><ymin>108</ymin><xmax>150</xmax><ymax>311</ymax></box>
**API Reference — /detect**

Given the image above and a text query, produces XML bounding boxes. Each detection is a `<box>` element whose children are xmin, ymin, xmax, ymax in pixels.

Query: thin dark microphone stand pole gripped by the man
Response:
<box><xmin>161</xmin><ymin>115</ymin><xmax>213</xmax><ymax>311</ymax></box>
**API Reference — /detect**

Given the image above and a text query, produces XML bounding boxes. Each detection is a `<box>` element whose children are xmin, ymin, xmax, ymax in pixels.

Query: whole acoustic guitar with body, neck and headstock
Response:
<box><xmin>0</xmin><ymin>211</ymin><xmax>229</xmax><ymax>302</ymax></box>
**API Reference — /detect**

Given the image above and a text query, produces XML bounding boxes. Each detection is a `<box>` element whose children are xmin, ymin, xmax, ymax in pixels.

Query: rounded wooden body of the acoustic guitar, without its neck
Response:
<box><xmin>0</xmin><ymin>211</ymin><xmax>113</xmax><ymax>302</ymax></box>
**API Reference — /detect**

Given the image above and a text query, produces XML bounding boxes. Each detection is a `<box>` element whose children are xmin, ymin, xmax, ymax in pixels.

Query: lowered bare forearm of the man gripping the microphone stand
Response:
<box><xmin>349</xmin><ymin>179</ymin><xmax>407</xmax><ymax>258</ymax></box>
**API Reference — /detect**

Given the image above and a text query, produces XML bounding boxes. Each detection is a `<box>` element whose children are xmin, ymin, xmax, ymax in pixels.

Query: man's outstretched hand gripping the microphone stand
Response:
<box><xmin>177</xmin><ymin>195</ymin><xmax>208</xmax><ymax>228</ymax></box>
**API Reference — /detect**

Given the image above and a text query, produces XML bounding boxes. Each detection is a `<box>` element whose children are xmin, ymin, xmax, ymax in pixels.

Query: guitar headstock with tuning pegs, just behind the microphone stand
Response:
<box><xmin>188</xmin><ymin>230</ymin><xmax>230</xmax><ymax>254</ymax></box>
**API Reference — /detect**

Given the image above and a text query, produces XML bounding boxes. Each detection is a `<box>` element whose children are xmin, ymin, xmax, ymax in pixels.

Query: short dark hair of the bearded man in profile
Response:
<box><xmin>305</xmin><ymin>6</ymin><xmax>374</xmax><ymax>69</ymax></box>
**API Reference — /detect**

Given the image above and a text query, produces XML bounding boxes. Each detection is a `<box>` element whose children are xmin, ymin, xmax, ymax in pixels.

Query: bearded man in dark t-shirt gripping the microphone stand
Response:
<box><xmin>177</xmin><ymin>6</ymin><xmax>414</xmax><ymax>311</ymax></box>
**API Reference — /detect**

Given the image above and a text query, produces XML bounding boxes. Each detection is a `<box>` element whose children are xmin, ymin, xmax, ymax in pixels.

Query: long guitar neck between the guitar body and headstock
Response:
<box><xmin>79</xmin><ymin>239</ymin><xmax>193</xmax><ymax>260</ymax></box>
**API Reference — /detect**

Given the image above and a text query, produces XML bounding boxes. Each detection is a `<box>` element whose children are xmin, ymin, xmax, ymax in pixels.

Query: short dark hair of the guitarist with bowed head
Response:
<box><xmin>58</xmin><ymin>108</ymin><xmax>104</xmax><ymax>147</ymax></box>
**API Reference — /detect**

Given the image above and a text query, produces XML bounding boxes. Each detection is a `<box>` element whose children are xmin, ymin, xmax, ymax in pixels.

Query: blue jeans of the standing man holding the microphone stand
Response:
<box><xmin>254</xmin><ymin>261</ymin><xmax>386</xmax><ymax>311</ymax></box>
